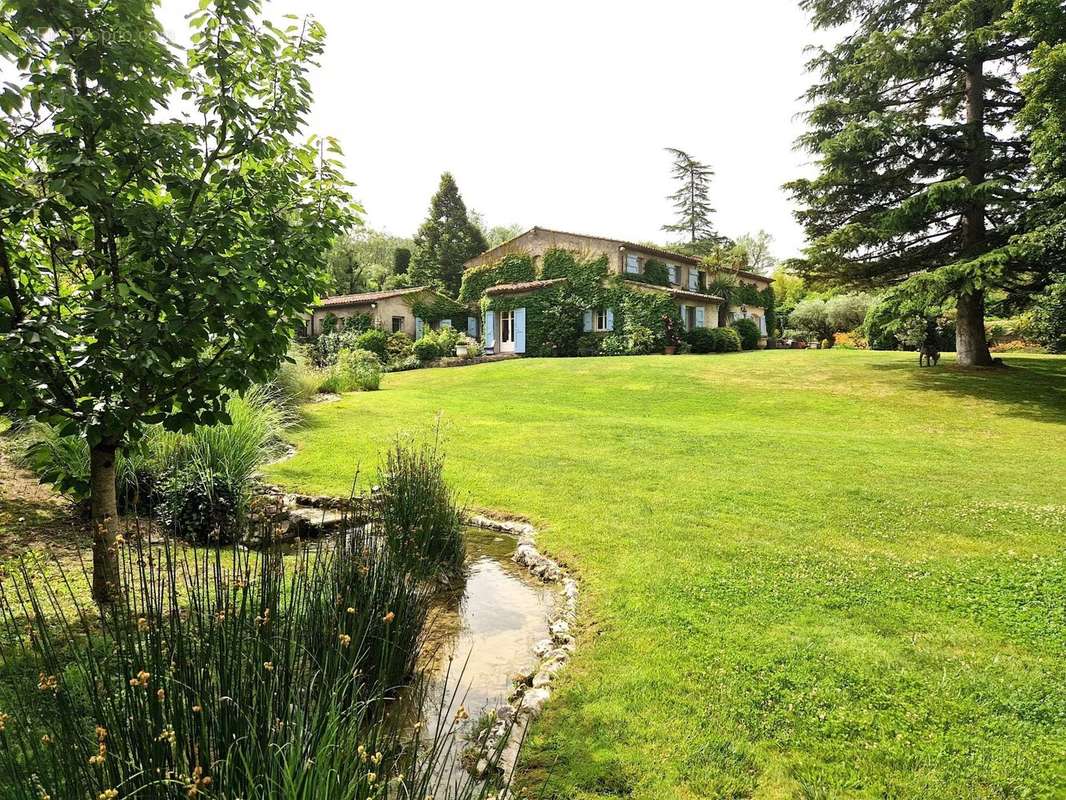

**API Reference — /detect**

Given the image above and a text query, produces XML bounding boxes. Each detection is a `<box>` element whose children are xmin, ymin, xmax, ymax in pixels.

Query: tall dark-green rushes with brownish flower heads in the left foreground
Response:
<box><xmin>0</xmin><ymin>516</ymin><xmax>505</xmax><ymax>800</ymax></box>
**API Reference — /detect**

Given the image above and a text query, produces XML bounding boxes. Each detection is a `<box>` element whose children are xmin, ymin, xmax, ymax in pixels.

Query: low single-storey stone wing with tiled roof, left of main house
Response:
<box><xmin>306</xmin><ymin>286</ymin><xmax>479</xmax><ymax>339</ymax></box>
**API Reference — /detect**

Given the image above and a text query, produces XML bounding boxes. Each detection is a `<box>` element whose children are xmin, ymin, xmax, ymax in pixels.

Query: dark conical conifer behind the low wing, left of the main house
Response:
<box><xmin>410</xmin><ymin>172</ymin><xmax>488</xmax><ymax>297</ymax></box>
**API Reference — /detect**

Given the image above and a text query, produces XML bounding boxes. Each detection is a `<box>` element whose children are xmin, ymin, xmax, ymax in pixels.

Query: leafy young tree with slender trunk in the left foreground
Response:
<box><xmin>0</xmin><ymin>0</ymin><xmax>351</xmax><ymax>603</ymax></box>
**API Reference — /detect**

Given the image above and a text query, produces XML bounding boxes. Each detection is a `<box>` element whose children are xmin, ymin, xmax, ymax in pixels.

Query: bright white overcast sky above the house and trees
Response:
<box><xmin>164</xmin><ymin>0</ymin><xmax>813</xmax><ymax>257</ymax></box>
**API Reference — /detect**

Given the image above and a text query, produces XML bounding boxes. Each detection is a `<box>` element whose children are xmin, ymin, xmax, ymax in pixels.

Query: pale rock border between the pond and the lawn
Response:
<box><xmin>465</xmin><ymin>513</ymin><xmax>578</xmax><ymax>785</ymax></box>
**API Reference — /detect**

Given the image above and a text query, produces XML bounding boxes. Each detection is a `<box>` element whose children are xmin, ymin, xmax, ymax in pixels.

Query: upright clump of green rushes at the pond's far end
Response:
<box><xmin>375</xmin><ymin>439</ymin><xmax>466</xmax><ymax>581</ymax></box>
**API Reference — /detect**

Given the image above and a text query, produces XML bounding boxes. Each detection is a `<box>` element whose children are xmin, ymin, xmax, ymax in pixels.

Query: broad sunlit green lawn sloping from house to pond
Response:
<box><xmin>271</xmin><ymin>351</ymin><xmax>1066</xmax><ymax>800</ymax></box>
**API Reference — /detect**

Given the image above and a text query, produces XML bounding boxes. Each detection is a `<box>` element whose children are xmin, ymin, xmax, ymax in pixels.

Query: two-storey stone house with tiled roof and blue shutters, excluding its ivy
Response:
<box><xmin>464</xmin><ymin>227</ymin><xmax>773</xmax><ymax>353</ymax></box>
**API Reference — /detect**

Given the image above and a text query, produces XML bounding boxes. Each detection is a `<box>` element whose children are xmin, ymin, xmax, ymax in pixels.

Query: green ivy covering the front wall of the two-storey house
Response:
<box><xmin>482</xmin><ymin>250</ymin><xmax>681</xmax><ymax>356</ymax></box>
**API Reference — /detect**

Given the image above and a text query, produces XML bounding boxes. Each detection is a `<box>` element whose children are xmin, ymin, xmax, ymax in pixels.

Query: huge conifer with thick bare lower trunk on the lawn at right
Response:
<box><xmin>788</xmin><ymin>0</ymin><xmax>1034</xmax><ymax>366</ymax></box>
